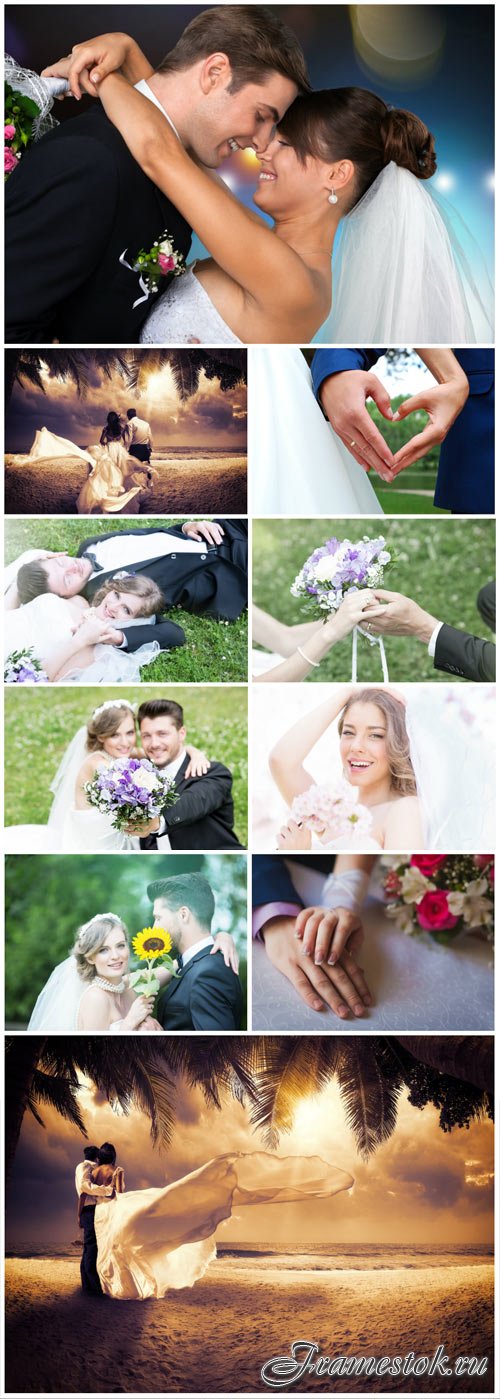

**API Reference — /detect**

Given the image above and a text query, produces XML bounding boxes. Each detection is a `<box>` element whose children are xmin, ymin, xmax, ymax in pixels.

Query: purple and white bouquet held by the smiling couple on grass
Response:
<box><xmin>84</xmin><ymin>758</ymin><xmax>179</xmax><ymax>831</ymax></box>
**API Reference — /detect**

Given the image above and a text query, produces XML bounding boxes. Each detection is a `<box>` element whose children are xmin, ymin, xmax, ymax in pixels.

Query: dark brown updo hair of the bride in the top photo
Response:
<box><xmin>279</xmin><ymin>88</ymin><xmax>437</xmax><ymax>213</ymax></box>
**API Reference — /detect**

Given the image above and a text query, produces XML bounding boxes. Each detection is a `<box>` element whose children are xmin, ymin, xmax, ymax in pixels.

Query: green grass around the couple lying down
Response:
<box><xmin>6</xmin><ymin>518</ymin><xmax>248</xmax><ymax>684</ymax></box>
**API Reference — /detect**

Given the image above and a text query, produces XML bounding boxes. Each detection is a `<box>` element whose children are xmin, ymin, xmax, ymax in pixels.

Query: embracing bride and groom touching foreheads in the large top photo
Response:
<box><xmin>6</xmin><ymin>4</ymin><xmax>493</xmax><ymax>346</ymax></box>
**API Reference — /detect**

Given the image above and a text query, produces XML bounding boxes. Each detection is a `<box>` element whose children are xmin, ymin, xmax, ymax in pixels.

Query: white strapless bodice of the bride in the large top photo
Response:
<box><xmin>140</xmin><ymin>263</ymin><xmax>244</xmax><ymax>346</ymax></box>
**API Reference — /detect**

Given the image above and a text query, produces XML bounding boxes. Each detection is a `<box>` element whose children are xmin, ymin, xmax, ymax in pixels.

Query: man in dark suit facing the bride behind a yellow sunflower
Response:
<box><xmin>147</xmin><ymin>873</ymin><xmax>242</xmax><ymax>1031</ymax></box>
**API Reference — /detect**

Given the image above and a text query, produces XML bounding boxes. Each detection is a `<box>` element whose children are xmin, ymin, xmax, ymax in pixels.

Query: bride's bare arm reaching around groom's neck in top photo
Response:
<box><xmin>99</xmin><ymin>73</ymin><xmax>312</xmax><ymax>315</ymax></box>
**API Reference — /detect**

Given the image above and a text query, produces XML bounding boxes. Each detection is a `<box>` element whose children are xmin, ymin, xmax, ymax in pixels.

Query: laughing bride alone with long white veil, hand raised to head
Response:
<box><xmin>256</xmin><ymin>686</ymin><xmax>494</xmax><ymax>852</ymax></box>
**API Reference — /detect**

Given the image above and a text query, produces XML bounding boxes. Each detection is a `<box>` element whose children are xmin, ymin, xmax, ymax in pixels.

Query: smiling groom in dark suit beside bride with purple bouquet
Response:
<box><xmin>136</xmin><ymin>700</ymin><xmax>241</xmax><ymax>851</ymax></box>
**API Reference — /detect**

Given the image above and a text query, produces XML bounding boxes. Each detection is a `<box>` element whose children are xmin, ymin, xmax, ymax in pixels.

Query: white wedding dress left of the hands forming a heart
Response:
<box><xmin>248</xmin><ymin>346</ymin><xmax>384</xmax><ymax>520</ymax></box>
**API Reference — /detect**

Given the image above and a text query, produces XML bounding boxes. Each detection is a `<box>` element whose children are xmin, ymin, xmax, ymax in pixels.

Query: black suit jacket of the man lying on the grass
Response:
<box><xmin>77</xmin><ymin>519</ymin><xmax>248</xmax><ymax>621</ymax></box>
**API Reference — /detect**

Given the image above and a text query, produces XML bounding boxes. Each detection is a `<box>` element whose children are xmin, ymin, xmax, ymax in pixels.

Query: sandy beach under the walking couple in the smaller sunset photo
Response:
<box><xmin>6</xmin><ymin>450</ymin><xmax>246</xmax><ymax>516</ymax></box>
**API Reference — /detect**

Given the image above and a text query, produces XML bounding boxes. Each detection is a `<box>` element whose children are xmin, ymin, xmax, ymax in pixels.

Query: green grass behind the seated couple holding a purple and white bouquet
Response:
<box><xmin>4</xmin><ymin>686</ymin><xmax>248</xmax><ymax>845</ymax></box>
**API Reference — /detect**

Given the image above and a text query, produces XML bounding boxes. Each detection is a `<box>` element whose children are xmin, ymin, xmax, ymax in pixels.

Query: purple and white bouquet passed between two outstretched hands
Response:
<box><xmin>290</xmin><ymin>534</ymin><xmax>394</xmax><ymax>617</ymax></box>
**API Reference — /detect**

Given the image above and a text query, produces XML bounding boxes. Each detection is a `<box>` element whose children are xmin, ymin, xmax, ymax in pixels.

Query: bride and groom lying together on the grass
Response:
<box><xmin>4</xmin><ymin>519</ymin><xmax>248</xmax><ymax>684</ymax></box>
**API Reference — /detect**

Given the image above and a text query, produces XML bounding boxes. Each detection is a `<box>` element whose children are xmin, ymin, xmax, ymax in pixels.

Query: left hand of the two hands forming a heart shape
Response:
<box><xmin>319</xmin><ymin>369</ymin><xmax>394</xmax><ymax>481</ymax></box>
